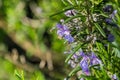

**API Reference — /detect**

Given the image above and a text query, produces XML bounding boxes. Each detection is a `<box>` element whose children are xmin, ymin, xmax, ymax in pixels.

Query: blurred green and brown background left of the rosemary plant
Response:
<box><xmin>0</xmin><ymin>0</ymin><xmax>68</xmax><ymax>80</ymax></box>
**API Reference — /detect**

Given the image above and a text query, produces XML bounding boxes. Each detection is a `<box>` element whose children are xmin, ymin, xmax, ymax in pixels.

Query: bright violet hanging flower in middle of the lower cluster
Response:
<box><xmin>80</xmin><ymin>56</ymin><xmax>90</xmax><ymax>75</ymax></box>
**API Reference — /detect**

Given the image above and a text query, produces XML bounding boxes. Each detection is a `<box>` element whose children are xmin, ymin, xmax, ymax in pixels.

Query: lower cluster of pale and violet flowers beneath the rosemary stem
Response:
<box><xmin>68</xmin><ymin>50</ymin><xmax>102</xmax><ymax>75</ymax></box>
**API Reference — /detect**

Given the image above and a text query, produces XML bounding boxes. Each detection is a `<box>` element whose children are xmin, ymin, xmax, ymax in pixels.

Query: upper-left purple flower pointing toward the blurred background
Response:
<box><xmin>57</xmin><ymin>24</ymin><xmax>74</xmax><ymax>43</ymax></box>
